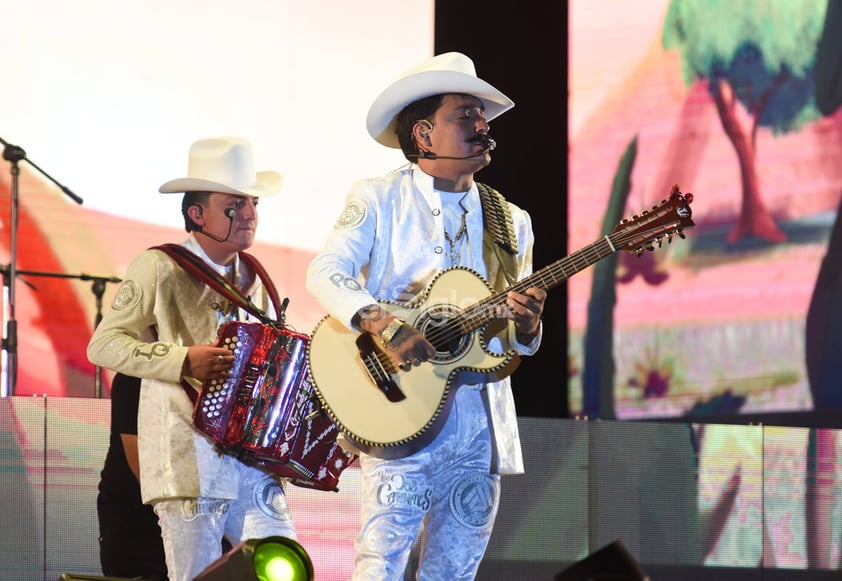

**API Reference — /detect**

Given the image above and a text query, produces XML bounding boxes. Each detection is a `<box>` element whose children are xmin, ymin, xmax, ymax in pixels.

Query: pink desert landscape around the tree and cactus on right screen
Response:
<box><xmin>568</xmin><ymin>0</ymin><xmax>842</xmax><ymax>418</ymax></box>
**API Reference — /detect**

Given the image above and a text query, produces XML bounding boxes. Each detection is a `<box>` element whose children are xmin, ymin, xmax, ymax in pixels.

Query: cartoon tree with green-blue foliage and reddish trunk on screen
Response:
<box><xmin>662</xmin><ymin>0</ymin><xmax>827</xmax><ymax>242</ymax></box>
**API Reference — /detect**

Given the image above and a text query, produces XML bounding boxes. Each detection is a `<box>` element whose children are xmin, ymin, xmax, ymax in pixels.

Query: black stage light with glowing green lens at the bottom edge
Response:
<box><xmin>193</xmin><ymin>537</ymin><xmax>313</xmax><ymax>581</ymax></box>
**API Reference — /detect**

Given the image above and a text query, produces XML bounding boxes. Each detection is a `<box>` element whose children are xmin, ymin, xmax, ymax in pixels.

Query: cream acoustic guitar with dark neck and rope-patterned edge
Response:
<box><xmin>307</xmin><ymin>186</ymin><xmax>695</xmax><ymax>458</ymax></box>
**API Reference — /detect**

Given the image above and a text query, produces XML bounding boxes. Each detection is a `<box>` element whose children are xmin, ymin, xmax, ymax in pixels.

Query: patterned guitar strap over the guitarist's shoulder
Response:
<box><xmin>477</xmin><ymin>182</ymin><xmax>518</xmax><ymax>291</ymax></box>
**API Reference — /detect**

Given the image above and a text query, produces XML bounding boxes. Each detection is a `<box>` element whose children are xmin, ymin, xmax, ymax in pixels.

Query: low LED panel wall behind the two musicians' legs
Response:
<box><xmin>0</xmin><ymin>397</ymin><xmax>842</xmax><ymax>581</ymax></box>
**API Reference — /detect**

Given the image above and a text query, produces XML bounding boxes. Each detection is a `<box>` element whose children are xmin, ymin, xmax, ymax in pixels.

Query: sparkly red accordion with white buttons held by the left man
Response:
<box><xmin>193</xmin><ymin>321</ymin><xmax>356</xmax><ymax>490</ymax></box>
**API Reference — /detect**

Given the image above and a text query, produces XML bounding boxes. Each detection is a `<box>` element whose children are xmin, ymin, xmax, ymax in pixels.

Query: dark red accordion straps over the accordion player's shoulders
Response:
<box><xmin>149</xmin><ymin>243</ymin><xmax>283</xmax><ymax>404</ymax></box>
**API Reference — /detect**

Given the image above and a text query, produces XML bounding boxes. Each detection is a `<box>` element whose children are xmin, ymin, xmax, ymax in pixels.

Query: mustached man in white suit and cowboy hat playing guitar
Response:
<box><xmin>307</xmin><ymin>53</ymin><xmax>546</xmax><ymax>580</ymax></box>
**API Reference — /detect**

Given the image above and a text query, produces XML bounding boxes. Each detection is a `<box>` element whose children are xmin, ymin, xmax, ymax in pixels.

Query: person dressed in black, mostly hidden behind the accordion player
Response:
<box><xmin>96</xmin><ymin>373</ymin><xmax>167</xmax><ymax>581</ymax></box>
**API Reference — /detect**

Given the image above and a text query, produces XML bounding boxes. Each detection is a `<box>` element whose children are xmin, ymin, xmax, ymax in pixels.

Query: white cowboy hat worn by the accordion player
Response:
<box><xmin>158</xmin><ymin>137</ymin><xmax>283</xmax><ymax>196</ymax></box>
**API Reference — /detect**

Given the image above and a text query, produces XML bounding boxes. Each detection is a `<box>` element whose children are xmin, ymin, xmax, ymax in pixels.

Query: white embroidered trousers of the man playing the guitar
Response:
<box><xmin>353</xmin><ymin>388</ymin><xmax>500</xmax><ymax>581</ymax></box>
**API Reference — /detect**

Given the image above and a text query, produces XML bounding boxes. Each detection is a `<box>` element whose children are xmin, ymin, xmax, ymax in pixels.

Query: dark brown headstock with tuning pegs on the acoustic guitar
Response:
<box><xmin>609</xmin><ymin>185</ymin><xmax>696</xmax><ymax>254</ymax></box>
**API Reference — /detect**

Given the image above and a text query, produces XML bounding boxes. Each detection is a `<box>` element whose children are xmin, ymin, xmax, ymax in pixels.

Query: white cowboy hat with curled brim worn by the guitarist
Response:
<box><xmin>366</xmin><ymin>52</ymin><xmax>515</xmax><ymax>147</ymax></box>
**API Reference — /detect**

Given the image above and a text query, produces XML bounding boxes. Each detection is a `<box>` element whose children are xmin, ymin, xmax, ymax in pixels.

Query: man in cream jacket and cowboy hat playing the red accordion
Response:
<box><xmin>88</xmin><ymin>137</ymin><xmax>295</xmax><ymax>581</ymax></box>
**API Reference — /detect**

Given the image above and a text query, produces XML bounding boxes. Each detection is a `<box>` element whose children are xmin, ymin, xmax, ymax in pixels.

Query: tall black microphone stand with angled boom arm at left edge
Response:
<box><xmin>0</xmin><ymin>137</ymin><xmax>82</xmax><ymax>396</ymax></box>
